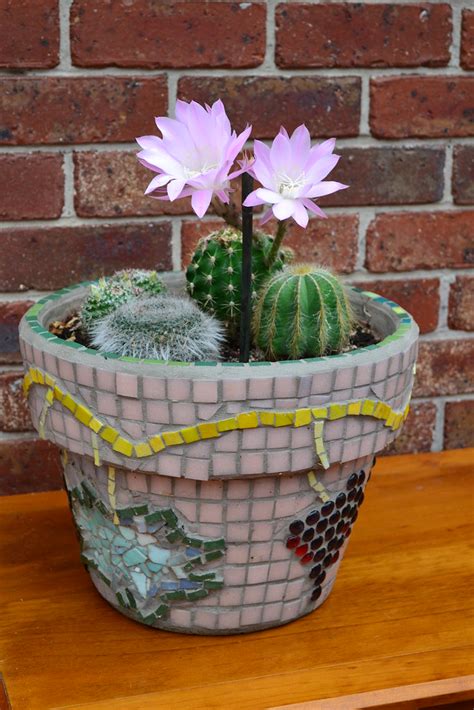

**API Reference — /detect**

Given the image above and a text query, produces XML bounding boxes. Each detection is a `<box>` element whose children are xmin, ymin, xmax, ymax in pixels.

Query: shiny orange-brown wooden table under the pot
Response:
<box><xmin>0</xmin><ymin>449</ymin><xmax>474</xmax><ymax>710</ymax></box>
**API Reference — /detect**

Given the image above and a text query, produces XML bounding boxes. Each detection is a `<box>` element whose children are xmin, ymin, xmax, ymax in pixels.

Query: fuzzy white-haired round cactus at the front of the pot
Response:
<box><xmin>91</xmin><ymin>294</ymin><xmax>223</xmax><ymax>362</ymax></box>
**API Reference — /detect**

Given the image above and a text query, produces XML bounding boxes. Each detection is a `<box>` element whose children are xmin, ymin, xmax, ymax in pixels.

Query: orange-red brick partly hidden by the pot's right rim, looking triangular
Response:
<box><xmin>354</xmin><ymin>279</ymin><xmax>439</xmax><ymax>333</ymax></box>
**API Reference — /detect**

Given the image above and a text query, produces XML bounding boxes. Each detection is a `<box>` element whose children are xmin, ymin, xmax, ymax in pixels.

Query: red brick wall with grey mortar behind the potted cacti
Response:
<box><xmin>0</xmin><ymin>0</ymin><xmax>474</xmax><ymax>490</ymax></box>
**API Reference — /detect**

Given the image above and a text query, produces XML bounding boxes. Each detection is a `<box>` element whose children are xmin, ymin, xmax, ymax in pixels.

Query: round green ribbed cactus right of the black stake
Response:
<box><xmin>252</xmin><ymin>264</ymin><xmax>352</xmax><ymax>360</ymax></box>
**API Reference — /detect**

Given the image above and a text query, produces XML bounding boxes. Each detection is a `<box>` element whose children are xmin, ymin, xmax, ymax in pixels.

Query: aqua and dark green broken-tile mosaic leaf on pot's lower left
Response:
<box><xmin>69</xmin><ymin>481</ymin><xmax>225</xmax><ymax>625</ymax></box>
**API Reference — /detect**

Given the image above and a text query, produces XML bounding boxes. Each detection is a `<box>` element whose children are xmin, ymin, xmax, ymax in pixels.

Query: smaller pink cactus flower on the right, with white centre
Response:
<box><xmin>244</xmin><ymin>124</ymin><xmax>348</xmax><ymax>227</ymax></box>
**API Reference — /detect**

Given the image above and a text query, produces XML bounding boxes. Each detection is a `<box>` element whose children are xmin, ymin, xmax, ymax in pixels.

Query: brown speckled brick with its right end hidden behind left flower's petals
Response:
<box><xmin>74</xmin><ymin>150</ymin><xmax>191</xmax><ymax>217</ymax></box>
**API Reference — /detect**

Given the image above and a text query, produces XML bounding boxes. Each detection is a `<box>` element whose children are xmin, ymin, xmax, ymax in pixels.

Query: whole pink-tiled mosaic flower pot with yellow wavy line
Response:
<box><xmin>20</xmin><ymin>274</ymin><xmax>418</xmax><ymax>634</ymax></box>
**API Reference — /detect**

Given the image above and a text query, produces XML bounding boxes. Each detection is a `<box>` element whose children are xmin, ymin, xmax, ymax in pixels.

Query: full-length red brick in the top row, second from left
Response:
<box><xmin>71</xmin><ymin>0</ymin><xmax>266</xmax><ymax>69</ymax></box>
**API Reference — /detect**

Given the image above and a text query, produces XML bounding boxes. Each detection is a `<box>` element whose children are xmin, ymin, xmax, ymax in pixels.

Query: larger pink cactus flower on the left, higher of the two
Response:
<box><xmin>136</xmin><ymin>100</ymin><xmax>252</xmax><ymax>217</ymax></box>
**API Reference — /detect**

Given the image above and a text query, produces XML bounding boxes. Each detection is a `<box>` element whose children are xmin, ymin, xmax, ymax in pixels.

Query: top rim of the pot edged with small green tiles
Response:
<box><xmin>20</xmin><ymin>272</ymin><xmax>419</xmax><ymax>377</ymax></box>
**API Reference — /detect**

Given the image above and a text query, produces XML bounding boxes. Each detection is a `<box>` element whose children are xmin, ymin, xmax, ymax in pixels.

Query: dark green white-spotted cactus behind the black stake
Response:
<box><xmin>186</xmin><ymin>227</ymin><xmax>289</xmax><ymax>336</ymax></box>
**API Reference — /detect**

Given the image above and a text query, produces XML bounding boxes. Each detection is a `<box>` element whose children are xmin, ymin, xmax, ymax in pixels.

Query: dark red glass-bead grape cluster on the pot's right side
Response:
<box><xmin>286</xmin><ymin>470</ymin><xmax>370</xmax><ymax>602</ymax></box>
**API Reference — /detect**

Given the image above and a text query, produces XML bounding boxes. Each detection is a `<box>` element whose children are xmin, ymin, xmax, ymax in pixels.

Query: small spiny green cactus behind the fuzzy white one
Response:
<box><xmin>80</xmin><ymin>269</ymin><xmax>165</xmax><ymax>331</ymax></box>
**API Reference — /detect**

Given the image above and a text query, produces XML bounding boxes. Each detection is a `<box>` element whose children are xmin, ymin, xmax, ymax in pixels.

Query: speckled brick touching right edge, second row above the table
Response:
<box><xmin>413</xmin><ymin>339</ymin><xmax>474</xmax><ymax>397</ymax></box>
